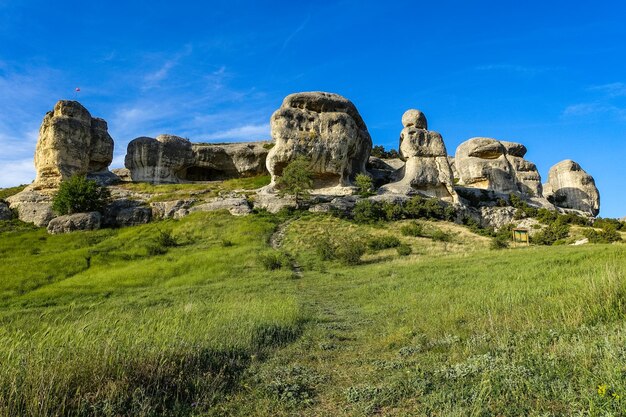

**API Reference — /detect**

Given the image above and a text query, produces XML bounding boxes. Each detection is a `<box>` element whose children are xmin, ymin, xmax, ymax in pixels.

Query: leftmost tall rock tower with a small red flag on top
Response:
<box><xmin>28</xmin><ymin>100</ymin><xmax>114</xmax><ymax>190</ymax></box>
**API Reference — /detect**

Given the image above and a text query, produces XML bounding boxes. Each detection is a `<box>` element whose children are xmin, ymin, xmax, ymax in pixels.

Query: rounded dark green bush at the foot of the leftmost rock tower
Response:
<box><xmin>52</xmin><ymin>175</ymin><xmax>111</xmax><ymax>215</ymax></box>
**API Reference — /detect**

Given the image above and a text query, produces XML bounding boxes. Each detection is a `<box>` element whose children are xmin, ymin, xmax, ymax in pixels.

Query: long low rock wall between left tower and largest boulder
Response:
<box><xmin>124</xmin><ymin>135</ymin><xmax>268</xmax><ymax>184</ymax></box>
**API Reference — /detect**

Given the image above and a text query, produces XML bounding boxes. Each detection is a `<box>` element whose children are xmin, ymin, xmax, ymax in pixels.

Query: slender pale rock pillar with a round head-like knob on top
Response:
<box><xmin>381</xmin><ymin>110</ymin><xmax>456</xmax><ymax>202</ymax></box>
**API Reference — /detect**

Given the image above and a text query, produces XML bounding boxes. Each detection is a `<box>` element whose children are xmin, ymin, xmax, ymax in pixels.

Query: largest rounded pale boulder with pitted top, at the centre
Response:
<box><xmin>267</xmin><ymin>92</ymin><xmax>372</xmax><ymax>194</ymax></box>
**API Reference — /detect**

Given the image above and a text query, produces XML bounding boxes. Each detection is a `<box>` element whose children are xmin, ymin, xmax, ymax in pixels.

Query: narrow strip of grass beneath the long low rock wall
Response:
<box><xmin>118</xmin><ymin>175</ymin><xmax>271</xmax><ymax>202</ymax></box>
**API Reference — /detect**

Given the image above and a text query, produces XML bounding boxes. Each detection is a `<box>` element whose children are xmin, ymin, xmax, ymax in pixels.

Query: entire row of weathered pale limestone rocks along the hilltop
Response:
<box><xmin>0</xmin><ymin>92</ymin><xmax>600</xmax><ymax>233</ymax></box>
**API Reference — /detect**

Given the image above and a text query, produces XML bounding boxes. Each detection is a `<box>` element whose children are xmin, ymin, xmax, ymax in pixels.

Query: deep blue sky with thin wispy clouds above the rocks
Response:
<box><xmin>0</xmin><ymin>0</ymin><xmax>626</xmax><ymax>217</ymax></box>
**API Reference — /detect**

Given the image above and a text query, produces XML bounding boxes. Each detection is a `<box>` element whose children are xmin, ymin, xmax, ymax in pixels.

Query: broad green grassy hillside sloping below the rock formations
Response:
<box><xmin>0</xmin><ymin>213</ymin><xmax>626</xmax><ymax>416</ymax></box>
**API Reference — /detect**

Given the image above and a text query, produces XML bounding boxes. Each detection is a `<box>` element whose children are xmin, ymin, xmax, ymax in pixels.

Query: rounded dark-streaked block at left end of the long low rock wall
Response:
<box><xmin>124</xmin><ymin>135</ymin><xmax>194</xmax><ymax>184</ymax></box>
